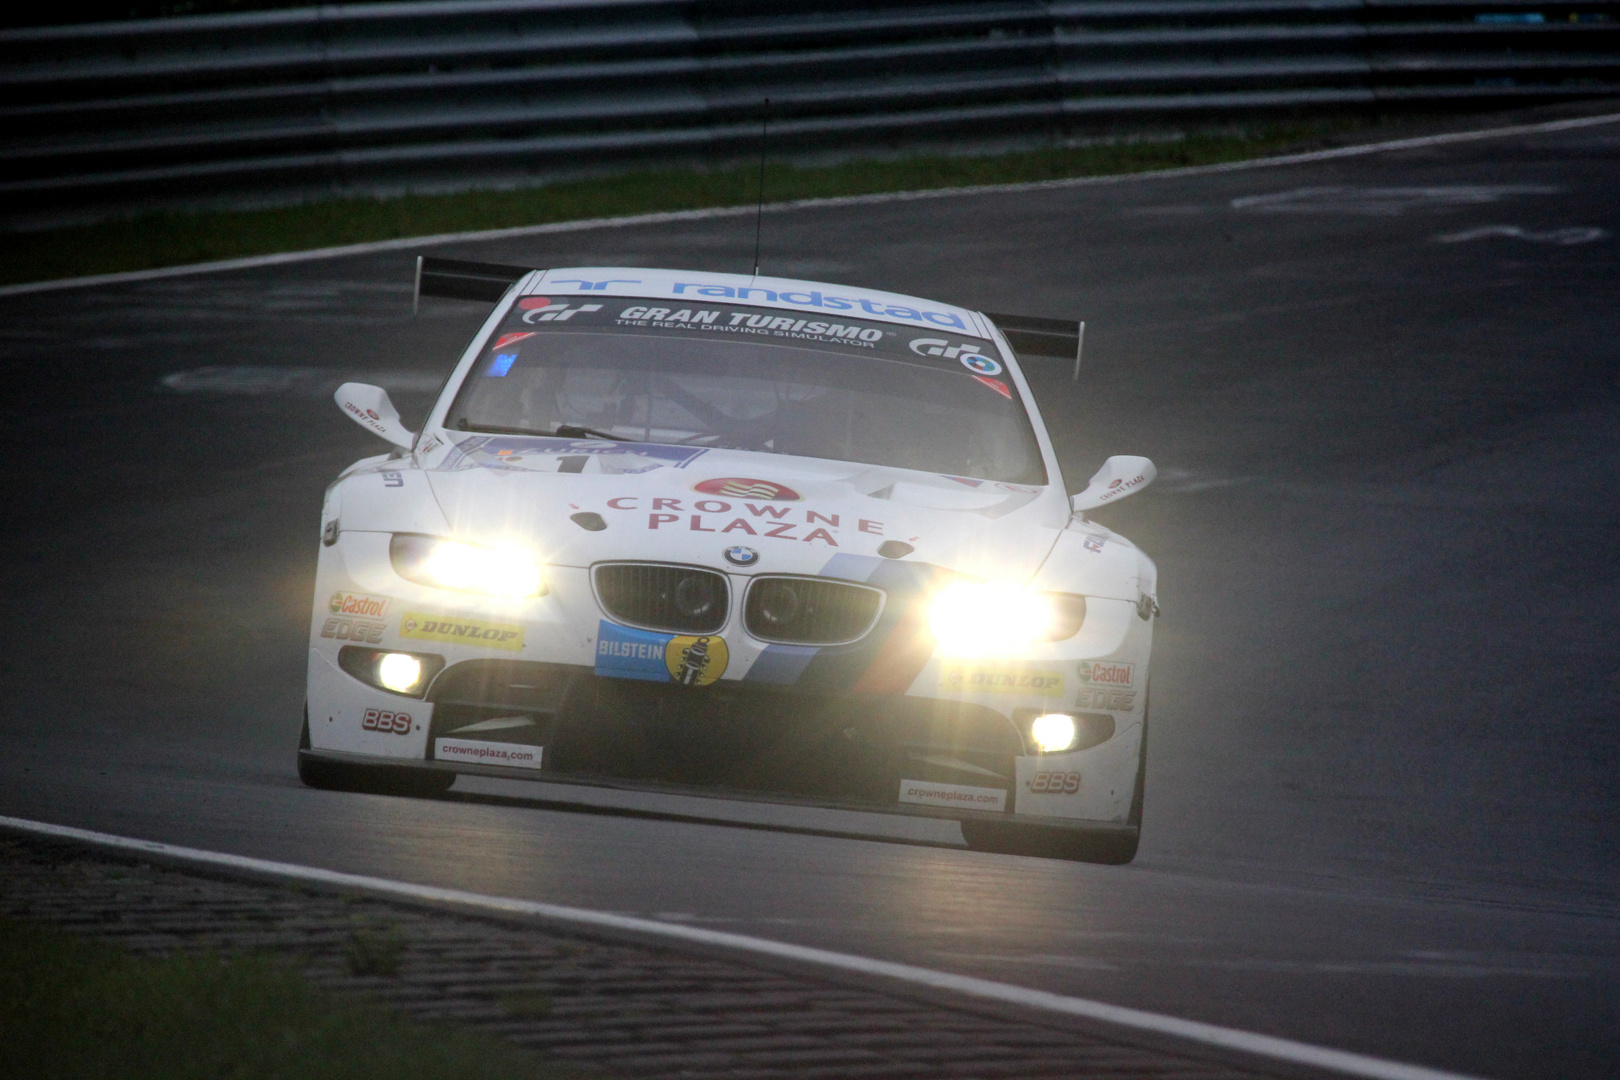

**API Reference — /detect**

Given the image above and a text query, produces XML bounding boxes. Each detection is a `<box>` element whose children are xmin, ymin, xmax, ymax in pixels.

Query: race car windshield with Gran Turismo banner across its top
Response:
<box><xmin>446</xmin><ymin>296</ymin><xmax>1047</xmax><ymax>484</ymax></box>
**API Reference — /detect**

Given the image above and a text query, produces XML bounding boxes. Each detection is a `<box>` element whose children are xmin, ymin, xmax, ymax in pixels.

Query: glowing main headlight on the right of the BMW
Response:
<box><xmin>928</xmin><ymin>581</ymin><xmax>1085</xmax><ymax>656</ymax></box>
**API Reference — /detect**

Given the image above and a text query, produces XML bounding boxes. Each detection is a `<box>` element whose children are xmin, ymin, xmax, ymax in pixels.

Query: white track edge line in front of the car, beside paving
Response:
<box><xmin>0</xmin><ymin>814</ymin><xmax>1477</xmax><ymax>1080</ymax></box>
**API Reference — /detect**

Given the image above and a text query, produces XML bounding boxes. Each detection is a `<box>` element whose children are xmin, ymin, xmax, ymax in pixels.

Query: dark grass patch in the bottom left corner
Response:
<box><xmin>0</xmin><ymin>920</ymin><xmax>595</xmax><ymax>1080</ymax></box>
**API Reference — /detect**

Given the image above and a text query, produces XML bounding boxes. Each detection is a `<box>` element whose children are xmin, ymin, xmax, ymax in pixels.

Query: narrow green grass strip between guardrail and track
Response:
<box><xmin>0</xmin><ymin>118</ymin><xmax>1369</xmax><ymax>285</ymax></box>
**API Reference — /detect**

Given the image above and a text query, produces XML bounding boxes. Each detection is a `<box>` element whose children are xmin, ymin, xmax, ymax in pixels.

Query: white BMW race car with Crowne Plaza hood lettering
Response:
<box><xmin>298</xmin><ymin>259</ymin><xmax>1158</xmax><ymax>861</ymax></box>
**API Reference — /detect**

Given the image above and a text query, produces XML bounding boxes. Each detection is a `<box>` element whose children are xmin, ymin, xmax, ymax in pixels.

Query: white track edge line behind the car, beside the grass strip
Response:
<box><xmin>0</xmin><ymin>113</ymin><xmax>1620</xmax><ymax>296</ymax></box>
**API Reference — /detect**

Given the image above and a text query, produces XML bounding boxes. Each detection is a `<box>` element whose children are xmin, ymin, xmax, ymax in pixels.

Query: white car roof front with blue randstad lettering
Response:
<box><xmin>523</xmin><ymin>266</ymin><xmax>990</xmax><ymax>337</ymax></box>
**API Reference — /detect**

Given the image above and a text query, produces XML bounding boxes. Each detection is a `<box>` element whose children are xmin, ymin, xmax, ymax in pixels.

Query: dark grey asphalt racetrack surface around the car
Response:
<box><xmin>0</xmin><ymin>111</ymin><xmax>1620</xmax><ymax>1078</ymax></box>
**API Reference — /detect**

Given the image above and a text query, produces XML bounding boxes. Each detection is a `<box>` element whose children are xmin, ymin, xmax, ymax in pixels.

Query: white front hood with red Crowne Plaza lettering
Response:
<box><xmin>421</xmin><ymin>436</ymin><xmax>1069</xmax><ymax>581</ymax></box>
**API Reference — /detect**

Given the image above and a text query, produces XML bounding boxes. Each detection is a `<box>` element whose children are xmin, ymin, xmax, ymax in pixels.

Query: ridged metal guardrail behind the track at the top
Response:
<box><xmin>0</xmin><ymin>0</ymin><xmax>1620</xmax><ymax>207</ymax></box>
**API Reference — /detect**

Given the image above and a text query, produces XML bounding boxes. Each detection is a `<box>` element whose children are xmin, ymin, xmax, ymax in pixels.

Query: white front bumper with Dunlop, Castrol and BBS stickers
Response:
<box><xmin>305</xmin><ymin>533</ymin><xmax>1152</xmax><ymax>829</ymax></box>
